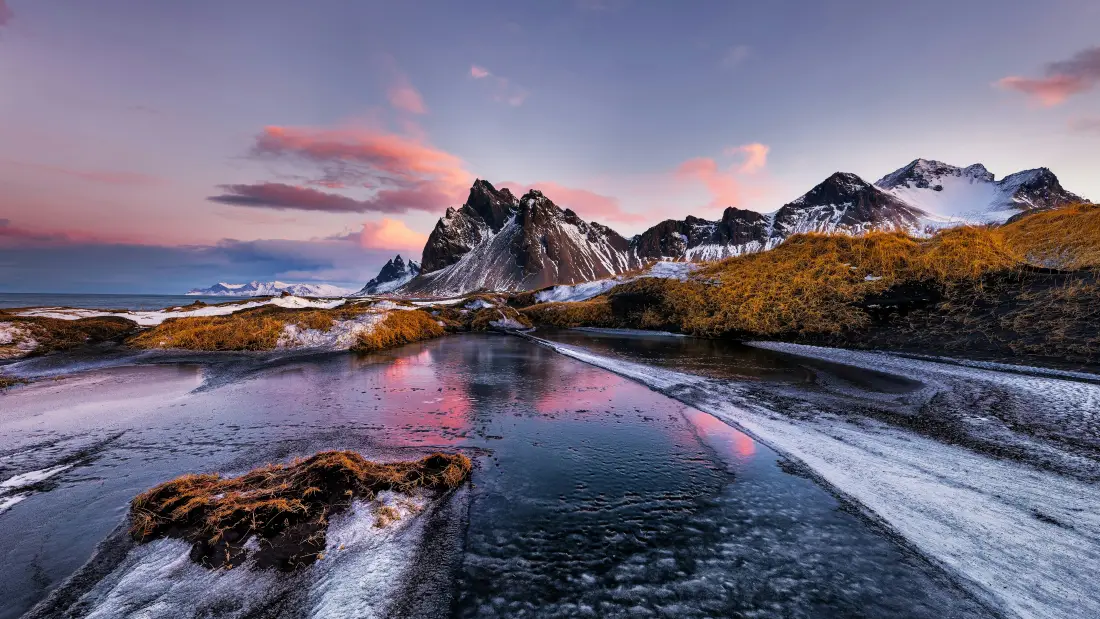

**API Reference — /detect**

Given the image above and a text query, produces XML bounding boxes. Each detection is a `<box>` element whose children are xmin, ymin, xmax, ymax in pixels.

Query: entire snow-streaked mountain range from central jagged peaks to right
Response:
<box><xmin>352</xmin><ymin>159</ymin><xmax>1088</xmax><ymax>296</ymax></box>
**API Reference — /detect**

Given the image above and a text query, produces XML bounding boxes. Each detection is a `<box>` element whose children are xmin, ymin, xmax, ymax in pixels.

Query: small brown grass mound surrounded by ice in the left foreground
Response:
<box><xmin>130</xmin><ymin>452</ymin><xmax>471</xmax><ymax>570</ymax></box>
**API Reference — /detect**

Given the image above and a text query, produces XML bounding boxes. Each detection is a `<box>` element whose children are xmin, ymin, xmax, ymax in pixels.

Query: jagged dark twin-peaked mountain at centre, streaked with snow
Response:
<box><xmin>400</xmin><ymin>180</ymin><xmax>641</xmax><ymax>296</ymax></box>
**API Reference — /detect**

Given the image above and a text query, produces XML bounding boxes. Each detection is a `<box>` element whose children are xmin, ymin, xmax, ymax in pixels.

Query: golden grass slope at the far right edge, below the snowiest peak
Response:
<box><xmin>1000</xmin><ymin>205</ymin><xmax>1100</xmax><ymax>269</ymax></box>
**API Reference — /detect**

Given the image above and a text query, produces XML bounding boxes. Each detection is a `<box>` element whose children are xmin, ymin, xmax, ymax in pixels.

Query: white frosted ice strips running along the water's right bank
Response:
<box><xmin>528</xmin><ymin>340</ymin><xmax>1100</xmax><ymax>619</ymax></box>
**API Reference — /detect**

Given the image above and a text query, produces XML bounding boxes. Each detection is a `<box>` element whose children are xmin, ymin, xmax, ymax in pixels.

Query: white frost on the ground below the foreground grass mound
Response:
<box><xmin>28</xmin><ymin>490</ymin><xmax>465</xmax><ymax>619</ymax></box>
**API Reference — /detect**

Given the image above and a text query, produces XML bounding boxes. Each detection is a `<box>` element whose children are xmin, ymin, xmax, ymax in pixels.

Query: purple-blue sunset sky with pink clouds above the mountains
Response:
<box><xmin>0</xmin><ymin>0</ymin><xmax>1100</xmax><ymax>294</ymax></box>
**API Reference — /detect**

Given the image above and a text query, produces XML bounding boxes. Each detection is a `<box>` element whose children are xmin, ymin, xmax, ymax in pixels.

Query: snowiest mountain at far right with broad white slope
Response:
<box><xmin>875</xmin><ymin>159</ymin><xmax>1087</xmax><ymax>229</ymax></box>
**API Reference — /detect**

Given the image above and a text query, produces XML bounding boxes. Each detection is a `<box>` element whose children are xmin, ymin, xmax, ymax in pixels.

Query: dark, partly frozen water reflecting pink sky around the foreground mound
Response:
<box><xmin>0</xmin><ymin>334</ymin><xmax>988</xmax><ymax>618</ymax></box>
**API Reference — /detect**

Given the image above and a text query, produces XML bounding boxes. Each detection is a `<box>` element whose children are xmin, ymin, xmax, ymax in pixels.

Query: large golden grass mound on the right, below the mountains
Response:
<box><xmin>523</xmin><ymin>228</ymin><xmax>1021</xmax><ymax>336</ymax></box>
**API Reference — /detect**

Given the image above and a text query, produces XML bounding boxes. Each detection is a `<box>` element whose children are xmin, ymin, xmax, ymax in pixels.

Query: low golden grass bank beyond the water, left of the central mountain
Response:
<box><xmin>129</xmin><ymin>303</ymin><xmax>371</xmax><ymax>351</ymax></box>
